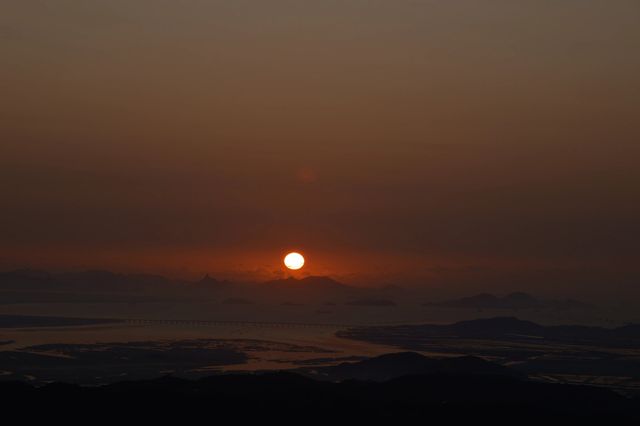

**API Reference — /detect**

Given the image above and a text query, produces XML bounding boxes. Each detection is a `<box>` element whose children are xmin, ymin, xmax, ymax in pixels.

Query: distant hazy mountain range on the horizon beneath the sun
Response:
<box><xmin>0</xmin><ymin>269</ymin><xmax>376</xmax><ymax>304</ymax></box>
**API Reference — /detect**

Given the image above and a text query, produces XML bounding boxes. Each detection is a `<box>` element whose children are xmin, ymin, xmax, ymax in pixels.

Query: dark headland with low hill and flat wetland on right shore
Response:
<box><xmin>337</xmin><ymin>317</ymin><xmax>640</xmax><ymax>395</ymax></box>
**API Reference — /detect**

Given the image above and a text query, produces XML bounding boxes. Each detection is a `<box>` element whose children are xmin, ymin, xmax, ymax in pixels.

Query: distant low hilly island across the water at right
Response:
<box><xmin>425</xmin><ymin>292</ymin><xmax>593</xmax><ymax>309</ymax></box>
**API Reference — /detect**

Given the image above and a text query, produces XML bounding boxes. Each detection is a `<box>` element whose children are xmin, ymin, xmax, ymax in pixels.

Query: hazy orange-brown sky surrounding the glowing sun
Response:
<box><xmin>0</xmin><ymin>0</ymin><xmax>640</xmax><ymax>296</ymax></box>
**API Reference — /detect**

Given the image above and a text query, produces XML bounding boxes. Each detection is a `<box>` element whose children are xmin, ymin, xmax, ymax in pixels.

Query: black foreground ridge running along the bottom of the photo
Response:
<box><xmin>0</xmin><ymin>373</ymin><xmax>640</xmax><ymax>424</ymax></box>
